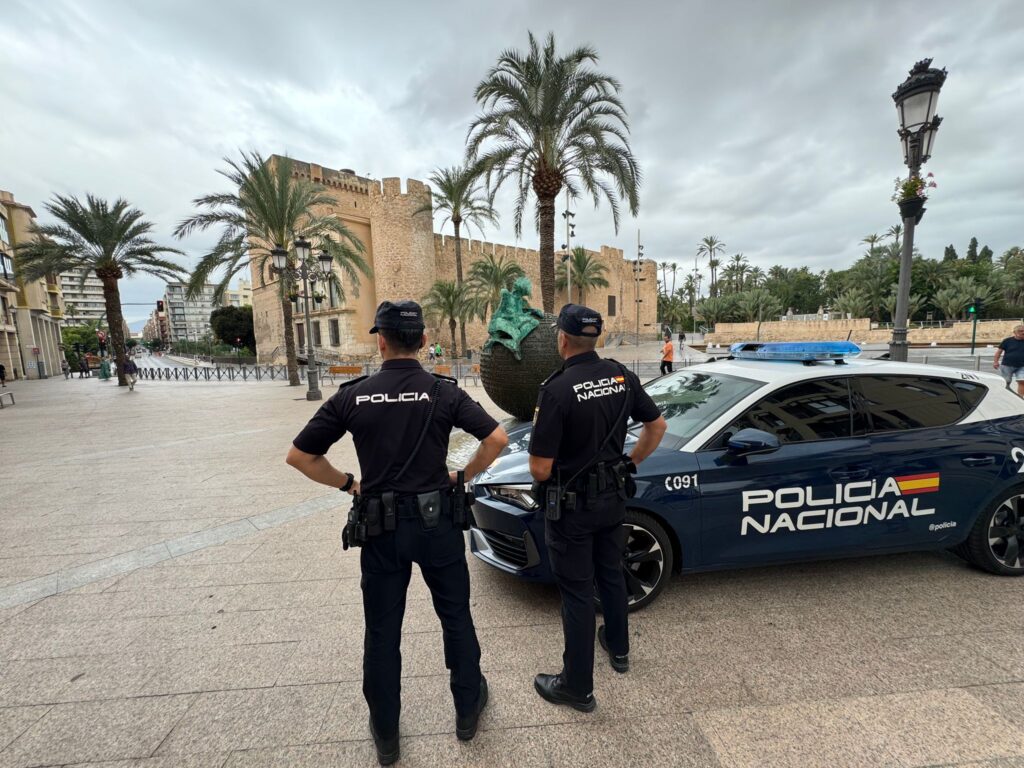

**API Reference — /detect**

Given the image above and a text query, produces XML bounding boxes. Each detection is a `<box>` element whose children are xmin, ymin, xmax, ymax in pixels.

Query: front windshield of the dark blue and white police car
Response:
<box><xmin>644</xmin><ymin>371</ymin><xmax>764</xmax><ymax>439</ymax></box>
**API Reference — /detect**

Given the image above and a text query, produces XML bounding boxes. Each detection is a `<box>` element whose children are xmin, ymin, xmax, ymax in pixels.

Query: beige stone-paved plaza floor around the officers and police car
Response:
<box><xmin>0</xmin><ymin>379</ymin><xmax>1024</xmax><ymax>768</ymax></box>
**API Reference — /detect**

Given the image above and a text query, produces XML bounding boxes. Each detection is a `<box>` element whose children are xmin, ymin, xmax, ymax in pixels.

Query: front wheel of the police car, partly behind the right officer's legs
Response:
<box><xmin>594</xmin><ymin>509</ymin><xmax>675</xmax><ymax>612</ymax></box>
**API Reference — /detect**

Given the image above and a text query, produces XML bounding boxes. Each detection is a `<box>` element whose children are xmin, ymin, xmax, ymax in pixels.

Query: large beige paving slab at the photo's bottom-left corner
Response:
<box><xmin>0</xmin><ymin>696</ymin><xmax>195</xmax><ymax>768</ymax></box>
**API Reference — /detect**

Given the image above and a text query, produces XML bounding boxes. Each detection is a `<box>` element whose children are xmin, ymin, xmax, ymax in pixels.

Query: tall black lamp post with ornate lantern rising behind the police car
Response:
<box><xmin>889</xmin><ymin>58</ymin><xmax>946</xmax><ymax>362</ymax></box>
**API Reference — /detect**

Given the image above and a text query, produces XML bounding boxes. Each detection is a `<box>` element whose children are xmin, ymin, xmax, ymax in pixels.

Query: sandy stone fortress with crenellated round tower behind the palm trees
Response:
<box><xmin>253</xmin><ymin>156</ymin><xmax>658</xmax><ymax>364</ymax></box>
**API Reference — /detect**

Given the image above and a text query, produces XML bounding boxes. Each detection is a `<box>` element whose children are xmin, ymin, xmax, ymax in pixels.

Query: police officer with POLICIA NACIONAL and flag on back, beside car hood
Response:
<box><xmin>529</xmin><ymin>304</ymin><xmax>667</xmax><ymax>712</ymax></box>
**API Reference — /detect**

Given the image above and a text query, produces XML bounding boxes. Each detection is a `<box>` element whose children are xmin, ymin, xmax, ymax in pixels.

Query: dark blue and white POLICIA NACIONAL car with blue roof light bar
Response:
<box><xmin>470</xmin><ymin>342</ymin><xmax>1024</xmax><ymax>608</ymax></box>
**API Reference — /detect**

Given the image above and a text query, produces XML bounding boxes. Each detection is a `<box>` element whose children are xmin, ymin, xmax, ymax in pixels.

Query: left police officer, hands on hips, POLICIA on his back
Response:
<box><xmin>287</xmin><ymin>301</ymin><xmax>508</xmax><ymax>765</ymax></box>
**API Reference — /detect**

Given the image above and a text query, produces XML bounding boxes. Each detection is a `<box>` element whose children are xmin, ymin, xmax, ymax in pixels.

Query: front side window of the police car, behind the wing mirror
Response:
<box><xmin>712</xmin><ymin>378</ymin><xmax>862</xmax><ymax>447</ymax></box>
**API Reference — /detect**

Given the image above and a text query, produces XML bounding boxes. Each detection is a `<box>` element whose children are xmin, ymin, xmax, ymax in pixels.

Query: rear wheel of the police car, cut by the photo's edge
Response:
<box><xmin>955</xmin><ymin>487</ymin><xmax>1024</xmax><ymax>575</ymax></box>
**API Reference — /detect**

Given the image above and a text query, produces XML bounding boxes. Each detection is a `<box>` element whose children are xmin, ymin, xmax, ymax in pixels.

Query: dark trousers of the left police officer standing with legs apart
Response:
<box><xmin>359</xmin><ymin>515</ymin><xmax>480</xmax><ymax>738</ymax></box>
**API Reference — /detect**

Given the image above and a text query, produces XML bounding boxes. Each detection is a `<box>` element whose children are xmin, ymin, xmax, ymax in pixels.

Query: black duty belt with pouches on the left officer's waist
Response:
<box><xmin>341</xmin><ymin>472</ymin><xmax>472</xmax><ymax>549</ymax></box>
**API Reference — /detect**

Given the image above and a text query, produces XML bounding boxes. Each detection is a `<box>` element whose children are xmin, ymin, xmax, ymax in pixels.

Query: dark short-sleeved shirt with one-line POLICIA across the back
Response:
<box><xmin>293</xmin><ymin>359</ymin><xmax>498</xmax><ymax>496</ymax></box>
